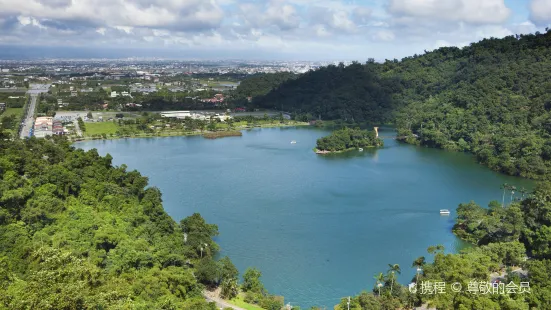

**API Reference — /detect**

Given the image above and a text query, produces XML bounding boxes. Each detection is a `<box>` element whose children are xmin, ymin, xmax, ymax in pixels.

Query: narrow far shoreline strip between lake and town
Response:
<box><xmin>68</xmin><ymin>122</ymin><xmax>310</xmax><ymax>143</ymax></box>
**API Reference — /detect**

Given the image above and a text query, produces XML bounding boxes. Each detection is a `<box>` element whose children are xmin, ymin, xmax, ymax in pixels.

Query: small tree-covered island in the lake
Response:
<box><xmin>314</xmin><ymin>127</ymin><xmax>383</xmax><ymax>154</ymax></box>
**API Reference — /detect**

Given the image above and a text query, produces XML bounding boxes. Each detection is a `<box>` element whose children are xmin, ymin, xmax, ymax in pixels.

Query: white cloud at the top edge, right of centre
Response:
<box><xmin>388</xmin><ymin>0</ymin><xmax>512</xmax><ymax>24</ymax></box>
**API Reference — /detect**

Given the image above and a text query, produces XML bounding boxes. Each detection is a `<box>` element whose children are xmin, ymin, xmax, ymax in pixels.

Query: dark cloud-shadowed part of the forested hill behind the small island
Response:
<box><xmin>253</xmin><ymin>63</ymin><xmax>393</xmax><ymax>123</ymax></box>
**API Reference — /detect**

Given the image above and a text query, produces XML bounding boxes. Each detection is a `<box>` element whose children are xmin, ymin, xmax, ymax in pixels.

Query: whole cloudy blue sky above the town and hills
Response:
<box><xmin>0</xmin><ymin>0</ymin><xmax>551</xmax><ymax>61</ymax></box>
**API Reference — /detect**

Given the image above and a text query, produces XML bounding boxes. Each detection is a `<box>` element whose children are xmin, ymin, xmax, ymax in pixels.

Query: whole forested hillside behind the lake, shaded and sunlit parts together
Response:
<box><xmin>253</xmin><ymin>31</ymin><xmax>551</xmax><ymax>178</ymax></box>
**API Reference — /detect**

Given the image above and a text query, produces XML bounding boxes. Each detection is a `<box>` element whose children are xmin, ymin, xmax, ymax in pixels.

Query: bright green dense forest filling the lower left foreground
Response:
<box><xmin>0</xmin><ymin>132</ymin><xmax>282</xmax><ymax>310</ymax></box>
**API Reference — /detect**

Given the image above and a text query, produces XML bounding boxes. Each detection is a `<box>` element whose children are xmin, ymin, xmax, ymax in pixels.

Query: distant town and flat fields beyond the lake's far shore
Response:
<box><xmin>0</xmin><ymin>59</ymin><xmax>322</xmax><ymax>140</ymax></box>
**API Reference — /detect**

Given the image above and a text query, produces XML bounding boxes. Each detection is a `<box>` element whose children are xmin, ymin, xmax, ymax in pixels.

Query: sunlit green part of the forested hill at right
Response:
<box><xmin>392</xmin><ymin>31</ymin><xmax>551</xmax><ymax>178</ymax></box>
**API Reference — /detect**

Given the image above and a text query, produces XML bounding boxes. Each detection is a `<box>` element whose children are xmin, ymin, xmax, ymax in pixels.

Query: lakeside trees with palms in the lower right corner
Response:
<box><xmin>338</xmin><ymin>181</ymin><xmax>551</xmax><ymax>310</ymax></box>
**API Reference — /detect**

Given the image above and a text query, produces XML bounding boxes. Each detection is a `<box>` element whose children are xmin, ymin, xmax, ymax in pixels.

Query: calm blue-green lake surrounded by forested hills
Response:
<box><xmin>76</xmin><ymin>127</ymin><xmax>533</xmax><ymax>309</ymax></box>
